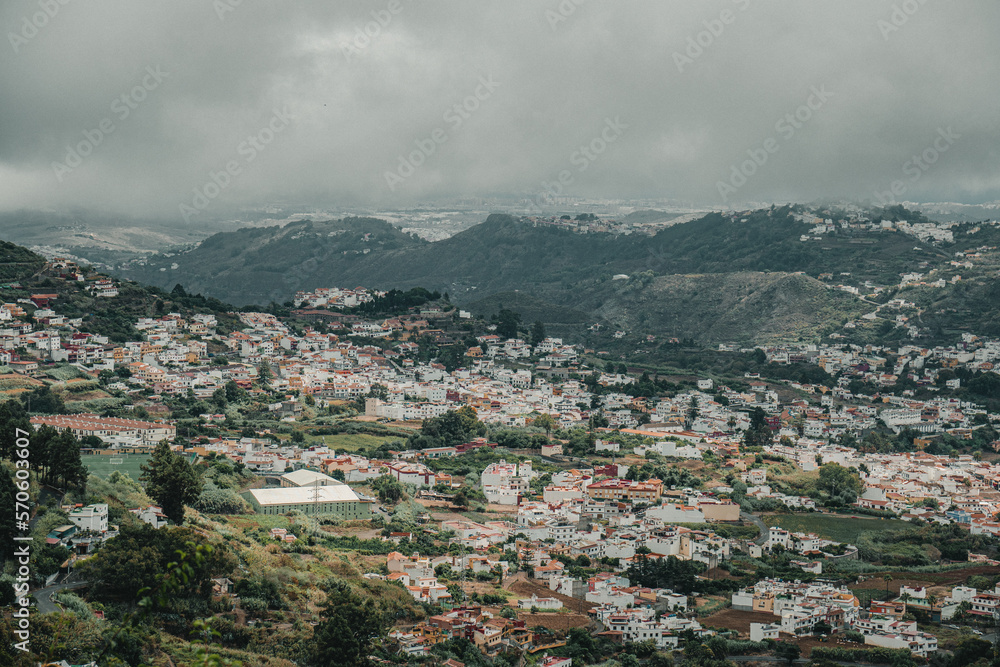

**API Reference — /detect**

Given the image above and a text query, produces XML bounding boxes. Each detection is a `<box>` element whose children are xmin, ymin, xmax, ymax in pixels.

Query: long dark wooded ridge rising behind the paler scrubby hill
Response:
<box><xmin>124</xmin><ymin>208</ymin><xmax>943</xmax><ymax>304</ymax></box>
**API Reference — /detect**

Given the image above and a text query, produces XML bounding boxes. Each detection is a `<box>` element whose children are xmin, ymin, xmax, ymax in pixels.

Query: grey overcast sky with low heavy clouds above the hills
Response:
<box><xmin>0</xmin><ymin>0</ymin><xmax>1000</xmax><ymax>220</ymax></box>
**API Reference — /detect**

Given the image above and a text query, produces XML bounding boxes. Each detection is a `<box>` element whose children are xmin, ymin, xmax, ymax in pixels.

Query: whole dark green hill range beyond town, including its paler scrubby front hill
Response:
<box><xmin>117</xmin><ymin>207</ymin><xmax>976</xmax><ymax>341</ymax></box>
